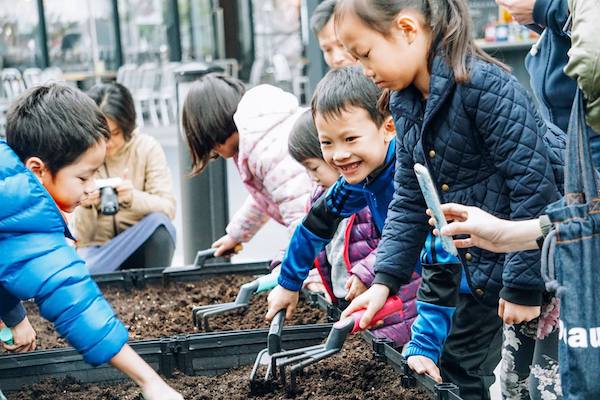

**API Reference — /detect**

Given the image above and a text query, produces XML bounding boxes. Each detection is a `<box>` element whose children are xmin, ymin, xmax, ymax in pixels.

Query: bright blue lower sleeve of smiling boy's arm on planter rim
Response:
<box><xmin>403</xmin><ymin>301</ymin><xmax>455</xmax><ymax>364</ymax></box>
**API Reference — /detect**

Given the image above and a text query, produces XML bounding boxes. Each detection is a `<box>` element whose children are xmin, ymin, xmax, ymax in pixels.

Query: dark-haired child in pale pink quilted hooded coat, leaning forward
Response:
<box><xmin>182</xmin><ymin>73</ymin><xmax>312</xmax><ymax>256</ymax></box>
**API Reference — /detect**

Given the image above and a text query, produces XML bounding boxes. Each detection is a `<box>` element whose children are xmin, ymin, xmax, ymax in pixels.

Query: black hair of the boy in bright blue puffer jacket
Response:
<box><xmin>6</xmin><ymin>83</ymin><xmax>110</xmax><ymax>176</ymax></box>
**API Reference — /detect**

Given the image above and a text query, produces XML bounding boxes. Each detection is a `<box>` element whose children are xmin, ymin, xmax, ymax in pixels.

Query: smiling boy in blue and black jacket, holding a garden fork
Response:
<box><xmin>266</xmin><ymin>67</ymin><xmax>461</xmax><ymax>362</ymax></box>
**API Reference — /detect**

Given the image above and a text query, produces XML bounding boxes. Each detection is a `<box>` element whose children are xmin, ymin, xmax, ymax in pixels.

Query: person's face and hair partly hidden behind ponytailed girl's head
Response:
<box><xmin>310</xmin><ymin>0</ymin><xmax>355</xmax><ymax>69</ymax></box>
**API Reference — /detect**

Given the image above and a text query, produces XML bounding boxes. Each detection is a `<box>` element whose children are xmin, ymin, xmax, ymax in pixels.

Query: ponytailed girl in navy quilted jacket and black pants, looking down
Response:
<box><xmin>335</xmin><ymin>0</ymin><xmax>560</xmax><ymax>399</ymax></box>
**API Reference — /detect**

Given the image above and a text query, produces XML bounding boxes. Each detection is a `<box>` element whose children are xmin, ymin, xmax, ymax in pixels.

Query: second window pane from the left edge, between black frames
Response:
<box><xmin>44</xmin><ymin>0</ymin><xmax>117</xmax><ymax>71</ymax></box>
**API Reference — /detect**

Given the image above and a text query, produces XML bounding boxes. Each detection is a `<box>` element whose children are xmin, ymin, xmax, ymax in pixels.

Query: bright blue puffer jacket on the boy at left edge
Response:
<box><xmin>0</xmin><ymin>141</ymin><xmax>128</xmax><ymax>365</ymax></box>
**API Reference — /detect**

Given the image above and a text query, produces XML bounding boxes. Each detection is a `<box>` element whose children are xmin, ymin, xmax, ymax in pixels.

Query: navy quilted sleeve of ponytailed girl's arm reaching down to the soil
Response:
<box><xmin>373</xmin><ymin>133</ymin><xmax>429</xmax><ymax>293</ymax></box>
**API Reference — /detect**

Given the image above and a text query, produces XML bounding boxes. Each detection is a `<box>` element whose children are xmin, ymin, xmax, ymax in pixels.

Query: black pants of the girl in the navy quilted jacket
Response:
<box><xmin>440</xmin><ymin>294</ymin><xmax>502</xmax><ymax>400</ymax></box>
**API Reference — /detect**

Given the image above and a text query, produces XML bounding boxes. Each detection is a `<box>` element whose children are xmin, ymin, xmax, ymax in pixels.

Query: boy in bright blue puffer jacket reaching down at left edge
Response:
<box><xmin>0</xmin><ymin>84</ymin><xmax>182</xmax><ymax>399</ymax></box>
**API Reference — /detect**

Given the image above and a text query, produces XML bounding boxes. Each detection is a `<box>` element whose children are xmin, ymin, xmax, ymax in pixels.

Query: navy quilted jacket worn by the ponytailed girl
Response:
<box><xmin>375</xmin><ymin>56</ymin><xmax>560</xmax><ymax>306</ymax></box>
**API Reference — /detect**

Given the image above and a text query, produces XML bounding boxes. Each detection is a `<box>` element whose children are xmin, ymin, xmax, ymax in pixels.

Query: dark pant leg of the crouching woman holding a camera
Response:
<box><xmin>119</xmin><ymin>225</ymin><xmax>175</xmax><ymax>269</ymax></box>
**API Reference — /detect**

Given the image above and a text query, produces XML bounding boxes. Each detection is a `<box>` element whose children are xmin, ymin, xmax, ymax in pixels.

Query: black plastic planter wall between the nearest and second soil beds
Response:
<box><xmin>0</xmin><ymin>324</ymin><xmax>331</xmax><ymax>392</ymax></box>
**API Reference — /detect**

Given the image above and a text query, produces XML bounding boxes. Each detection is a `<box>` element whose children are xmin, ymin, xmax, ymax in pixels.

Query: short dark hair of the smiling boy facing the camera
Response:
<box><xmin>312</xmin><ymin>65</ymin><xmax>389</xmax><ymax>127</ymax></box>
